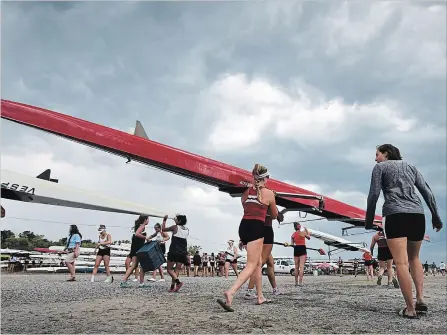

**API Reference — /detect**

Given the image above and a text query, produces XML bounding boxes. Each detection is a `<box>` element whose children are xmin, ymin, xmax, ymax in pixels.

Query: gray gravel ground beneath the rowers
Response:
<box><xmin>1</xmin><ymin>274</ymin><xmax>447</xmax><ymax>334</ymax></box>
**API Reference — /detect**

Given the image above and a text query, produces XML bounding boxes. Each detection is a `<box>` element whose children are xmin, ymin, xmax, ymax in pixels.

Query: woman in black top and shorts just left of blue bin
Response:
<box><xmin>120</xmin><ymin>215</ymin><xmax>149</xmax><ymax>287</ymax></box>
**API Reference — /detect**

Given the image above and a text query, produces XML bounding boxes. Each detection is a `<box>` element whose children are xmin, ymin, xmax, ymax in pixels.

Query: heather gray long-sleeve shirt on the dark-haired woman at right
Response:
<box><xmin>365</xmin><ymin>160</ymin><xmax>440</xmax><ymax>227</ymax></box>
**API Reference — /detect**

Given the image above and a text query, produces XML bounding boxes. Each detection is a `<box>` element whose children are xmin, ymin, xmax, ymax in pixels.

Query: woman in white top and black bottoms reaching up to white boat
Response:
<box><xmin>161</xmin><ymin>214</ymin><xmax>189</xmax><ymax>292</ymax></box>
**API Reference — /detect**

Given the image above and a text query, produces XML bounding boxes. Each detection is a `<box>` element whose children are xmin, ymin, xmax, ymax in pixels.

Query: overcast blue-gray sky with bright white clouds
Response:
<box><xmin>1</xmin><ymin>1</ymin><xmax>447</xmax><ymax>262</ymax></box>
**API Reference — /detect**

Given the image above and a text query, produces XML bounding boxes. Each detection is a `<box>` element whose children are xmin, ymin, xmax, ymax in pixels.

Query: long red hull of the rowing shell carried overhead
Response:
<box><xmin>1</xmin><ymin>100</ymin><xmax>381</xmax><ymax>225</ymax></box>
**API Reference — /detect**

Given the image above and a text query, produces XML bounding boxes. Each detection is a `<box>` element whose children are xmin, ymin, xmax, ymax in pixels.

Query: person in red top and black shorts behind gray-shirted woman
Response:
<box><xmin>369</xmin><ymin>231</ymin><xmax>399</xmax><ymax>288</ymax></box>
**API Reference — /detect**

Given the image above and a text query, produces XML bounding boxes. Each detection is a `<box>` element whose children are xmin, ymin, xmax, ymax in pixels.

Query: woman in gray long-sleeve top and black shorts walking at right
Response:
<box><xmin>365</xmin><ymin>144</ymin><xmax>442</xmax><ymax>318</ymax></box>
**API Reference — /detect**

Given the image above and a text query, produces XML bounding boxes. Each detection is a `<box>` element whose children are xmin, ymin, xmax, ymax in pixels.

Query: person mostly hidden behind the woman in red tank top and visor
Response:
<box><xmin>245</xmin><ymin>207</ymin><xmax>284</xmax><ymax>299</ymax></box>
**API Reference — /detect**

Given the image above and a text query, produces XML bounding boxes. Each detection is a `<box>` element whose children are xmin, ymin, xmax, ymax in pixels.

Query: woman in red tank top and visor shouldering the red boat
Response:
<box><xmin>217</xmin><ymin>164</ymin><xmax>278</xmax><ymax>312</ymax></box>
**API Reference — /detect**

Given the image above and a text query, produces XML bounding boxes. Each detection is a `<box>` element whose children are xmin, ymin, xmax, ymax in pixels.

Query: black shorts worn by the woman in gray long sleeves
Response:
<box><xmin>383</xmin><ymin>213</ymin><xmax>425</xmax><ymax>241</ymax></box>
